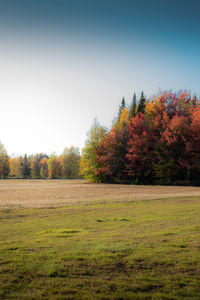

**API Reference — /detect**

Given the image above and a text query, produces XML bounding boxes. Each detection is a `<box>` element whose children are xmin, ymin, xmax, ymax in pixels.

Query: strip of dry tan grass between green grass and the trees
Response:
<box><xmin>0</xmin><ymin>180</ymin><xmax>200</xmax><ymax>208</ymax></box>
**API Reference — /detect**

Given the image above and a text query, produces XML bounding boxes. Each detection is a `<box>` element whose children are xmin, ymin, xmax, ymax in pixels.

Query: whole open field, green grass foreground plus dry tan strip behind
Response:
<box><xmin>0</xmin><ymin>180</ymin><xmax>200</xmax><ymax>300</ymax></box>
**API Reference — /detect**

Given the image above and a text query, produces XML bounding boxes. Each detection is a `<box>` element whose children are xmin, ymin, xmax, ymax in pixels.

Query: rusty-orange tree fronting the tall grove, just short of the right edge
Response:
<box><xmin>154</xmin><ymin>115</ymin><xmax>190</xmax><ymax>184</ymax></box>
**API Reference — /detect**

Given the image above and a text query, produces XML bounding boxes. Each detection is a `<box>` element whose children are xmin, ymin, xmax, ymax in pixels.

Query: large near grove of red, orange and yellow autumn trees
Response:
<box><xmin>81</xmin><ymin>91</ymin><xmax>200</xmax><ymax>185</ymax></box>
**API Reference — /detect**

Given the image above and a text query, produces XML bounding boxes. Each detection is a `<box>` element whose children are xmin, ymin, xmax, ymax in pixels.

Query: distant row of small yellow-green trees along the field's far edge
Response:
<box><xmin>0</xmin><ymin>143</ymin><xmax>80</xmax><ymax>179</ymax></box>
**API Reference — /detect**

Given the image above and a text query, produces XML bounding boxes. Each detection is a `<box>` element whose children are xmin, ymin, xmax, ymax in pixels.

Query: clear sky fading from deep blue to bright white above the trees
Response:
<box><xmin>0</xmin><ymin>0</ymin><xmax>200</xmax><ymax>155</ymax></box>
